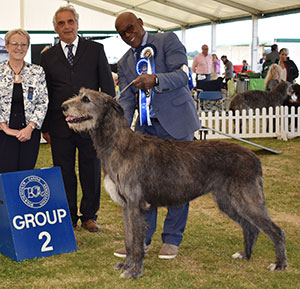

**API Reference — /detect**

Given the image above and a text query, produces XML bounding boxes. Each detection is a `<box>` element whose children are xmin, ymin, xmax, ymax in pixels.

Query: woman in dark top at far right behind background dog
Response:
<box><xmin>275</xmin><ymin>48</ymin><xmax>299</xmax><ymax>83</ymax></box>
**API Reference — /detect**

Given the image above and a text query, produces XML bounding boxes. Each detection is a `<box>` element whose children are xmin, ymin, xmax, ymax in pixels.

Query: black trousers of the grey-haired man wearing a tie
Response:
<box><xmin>51</xmin><ymin>132</ymin><xmax>101</xmax><ymax>224</ymax></box>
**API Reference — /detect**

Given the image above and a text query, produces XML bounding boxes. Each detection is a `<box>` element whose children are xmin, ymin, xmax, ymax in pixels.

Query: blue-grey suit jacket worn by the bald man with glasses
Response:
<box><xmin>118</xmin><ymin>32</ymin><xmax>200</xmax><ymax>139</ymax></box>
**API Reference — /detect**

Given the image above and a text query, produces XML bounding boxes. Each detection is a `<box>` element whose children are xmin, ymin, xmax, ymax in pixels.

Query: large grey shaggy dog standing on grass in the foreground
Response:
<box><xmin>62</xmin><ymin>88</ymin><xmax>287</xmax><ymax>278</ymax></box>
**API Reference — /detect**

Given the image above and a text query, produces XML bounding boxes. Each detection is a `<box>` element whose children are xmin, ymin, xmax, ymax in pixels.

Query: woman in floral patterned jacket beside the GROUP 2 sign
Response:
<box><xmin>0</xmin><ymin>29</ymin><xmax>48</xmax><ymax>173</ymax></box>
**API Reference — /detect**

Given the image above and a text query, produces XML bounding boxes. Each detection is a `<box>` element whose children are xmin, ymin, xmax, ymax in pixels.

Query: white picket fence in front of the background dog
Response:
<box><xmin>196</xmin><ymin>106</ymin><xmax>300</xmax><ymax>140</ymax></box>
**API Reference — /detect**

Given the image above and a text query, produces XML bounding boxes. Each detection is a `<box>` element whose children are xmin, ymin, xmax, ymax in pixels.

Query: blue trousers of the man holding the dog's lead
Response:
<box><xmin>143</xmin><ymin>121</ymin><xmax>194</xmax><ymax>246</ymax></box>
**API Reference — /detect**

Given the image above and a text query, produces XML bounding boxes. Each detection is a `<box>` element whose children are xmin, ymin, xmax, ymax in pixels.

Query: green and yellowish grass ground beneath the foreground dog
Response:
<box><xmin>0</xmin><ymin>139</ymin><xmax>300</xmax><ymax>289</ymax></box>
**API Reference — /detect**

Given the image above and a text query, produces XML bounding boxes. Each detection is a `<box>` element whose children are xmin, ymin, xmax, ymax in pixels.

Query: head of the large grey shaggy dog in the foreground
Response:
<box><xmin>61</xmin><ymin>88</ymin><xmax>124</xmax><ymax>132</ymax></box>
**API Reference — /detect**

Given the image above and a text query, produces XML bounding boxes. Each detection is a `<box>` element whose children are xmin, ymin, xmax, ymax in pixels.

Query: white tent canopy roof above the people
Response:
<box><xmin>0</xmin><ymin>0</ymin><xmax>300</xmax><ymax>33</ymax></box>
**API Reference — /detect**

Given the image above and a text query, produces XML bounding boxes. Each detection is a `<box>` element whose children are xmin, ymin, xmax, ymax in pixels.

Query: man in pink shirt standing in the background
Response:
<box><xmin>192</xmin><ymin>44</ymin><xmax>212</xmax><ymax>80</ymax></box>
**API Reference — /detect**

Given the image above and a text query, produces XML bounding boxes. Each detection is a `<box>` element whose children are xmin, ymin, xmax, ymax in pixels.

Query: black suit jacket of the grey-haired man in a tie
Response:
<box><xmin>41</xmin><ymin>38</ymin><xmax>115</xmax><ymax>137</ymax></box>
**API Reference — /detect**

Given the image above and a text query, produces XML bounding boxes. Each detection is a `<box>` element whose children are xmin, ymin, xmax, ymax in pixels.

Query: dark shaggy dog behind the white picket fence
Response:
<box><xmin>229</xmin><ymin>81</ymin><xmax>290</xmax><ymax>111</ymax></box>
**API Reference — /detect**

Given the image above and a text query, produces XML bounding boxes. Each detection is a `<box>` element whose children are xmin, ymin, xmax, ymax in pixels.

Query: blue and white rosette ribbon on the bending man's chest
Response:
<box><xmin>135</xmin><ymin>44</ymin><xmax>156</xmax><ymax>126</ymax></box>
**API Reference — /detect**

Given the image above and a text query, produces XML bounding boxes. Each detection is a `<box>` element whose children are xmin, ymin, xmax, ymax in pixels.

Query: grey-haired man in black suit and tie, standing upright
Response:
<box><xmin>41</xmin><ymin>5</ymin><xmax>115</xmax><ymax>232</ymax></box>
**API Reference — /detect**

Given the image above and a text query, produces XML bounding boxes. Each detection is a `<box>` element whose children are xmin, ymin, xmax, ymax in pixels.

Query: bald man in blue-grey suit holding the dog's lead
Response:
<box><xmin>114</xmin><ymin>12</ymin><xmax>200</xmax><ymax>259</ymax></box>
